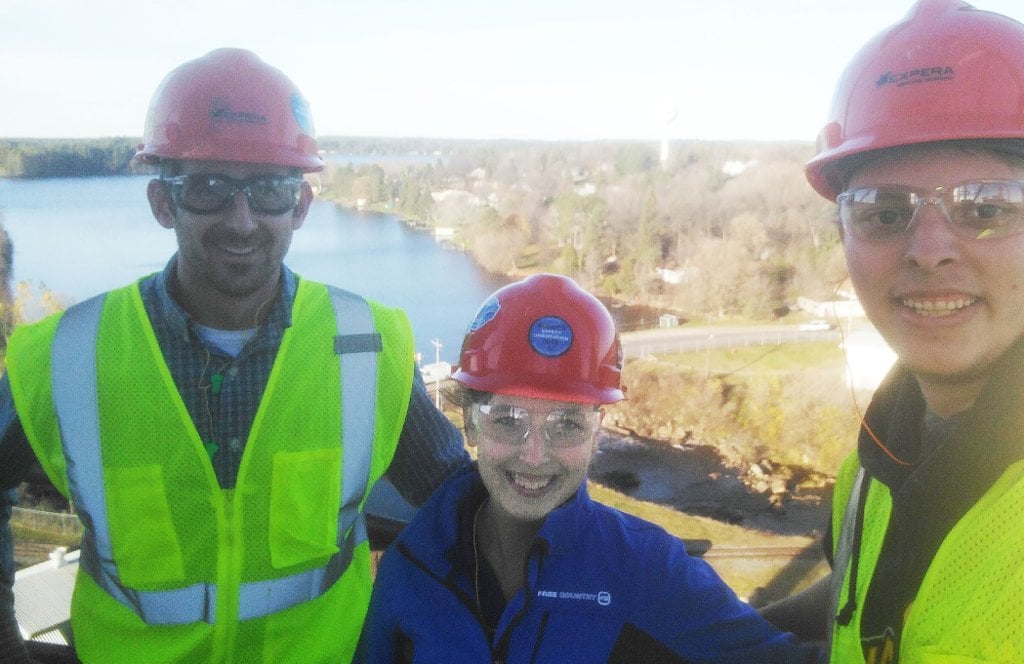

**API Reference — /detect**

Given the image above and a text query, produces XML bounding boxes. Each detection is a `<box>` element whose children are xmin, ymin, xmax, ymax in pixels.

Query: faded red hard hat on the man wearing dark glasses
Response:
<box><xmin>136</xmin><ymin>48</ymin><xmax>324</xmax><ymax>172</ymax></box>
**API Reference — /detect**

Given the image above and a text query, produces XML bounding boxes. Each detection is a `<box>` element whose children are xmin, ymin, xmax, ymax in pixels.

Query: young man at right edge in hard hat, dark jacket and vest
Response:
<box><xmin>764</xmin><ymin>0</ymin><xmax>1024</xmax><ymax>664</ymax></box>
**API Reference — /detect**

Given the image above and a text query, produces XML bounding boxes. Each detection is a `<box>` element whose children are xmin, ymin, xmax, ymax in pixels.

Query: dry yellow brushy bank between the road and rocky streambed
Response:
<box><xmin>605</xmin><ymin>343</ymin><xmax>859</xmax><ymax>473</ymax></box>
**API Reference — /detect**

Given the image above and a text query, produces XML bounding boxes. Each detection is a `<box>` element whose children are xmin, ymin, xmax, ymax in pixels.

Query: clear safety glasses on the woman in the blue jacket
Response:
<box><xmin>470</xmin><ymin>404</ymin><xmax>601</xmax><ymax>448</ymax></box>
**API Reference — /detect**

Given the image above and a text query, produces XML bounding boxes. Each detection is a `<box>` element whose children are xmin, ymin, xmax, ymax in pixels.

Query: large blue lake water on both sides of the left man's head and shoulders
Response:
<box><xmin>0</xmin><ymin>175</ymin><xmax>507</xmax><ymax>364</ymax></box>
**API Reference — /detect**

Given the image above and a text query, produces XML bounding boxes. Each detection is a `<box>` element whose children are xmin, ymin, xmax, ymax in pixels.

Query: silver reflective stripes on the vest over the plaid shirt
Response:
<box><xmin>51</xmin><ymin>288</ymin><xmax>381</xmax><ymax>625</ymax></box>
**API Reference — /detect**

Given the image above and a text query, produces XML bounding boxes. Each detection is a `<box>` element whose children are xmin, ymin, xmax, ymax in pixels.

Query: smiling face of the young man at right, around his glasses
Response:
<box><xmin>843</xmin><ymin>147</ymin><xmax>1024</xmax><ymax>415</ymax></box>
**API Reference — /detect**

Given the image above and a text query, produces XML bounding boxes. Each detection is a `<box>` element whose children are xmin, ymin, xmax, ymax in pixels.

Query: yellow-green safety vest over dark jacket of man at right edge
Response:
<box><xmin>829</xmin><ymin>453</ymin><xmax>1024</xmax><ymax>664</ymax></box>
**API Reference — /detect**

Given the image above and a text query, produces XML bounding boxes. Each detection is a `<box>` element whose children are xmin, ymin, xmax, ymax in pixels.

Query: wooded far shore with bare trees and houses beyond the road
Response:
<box><xmin>321</xmin><ymin>141</ymin><xmax>845</xmax><ymax>320</ymax></box>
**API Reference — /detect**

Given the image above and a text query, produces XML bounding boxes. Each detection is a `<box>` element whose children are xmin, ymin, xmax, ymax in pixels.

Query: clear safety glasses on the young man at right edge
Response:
<box><xmin>836</xmin><ymin>180</ymin><xmax>1024</xmax><ymax>242</ymax></box>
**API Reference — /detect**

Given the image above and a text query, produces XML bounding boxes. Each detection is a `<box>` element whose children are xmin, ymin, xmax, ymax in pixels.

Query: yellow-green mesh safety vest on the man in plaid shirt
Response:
<box><xmin>7</xmin><ymin>280</ymin><xmax>414</xmax><ymax>664</ymax></box>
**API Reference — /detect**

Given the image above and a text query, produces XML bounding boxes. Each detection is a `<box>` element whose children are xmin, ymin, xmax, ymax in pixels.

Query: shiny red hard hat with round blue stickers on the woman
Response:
<box><xmin>454</xmin><ymin>275</ymin><xmax>625</xmax><ymax>404</ymax></box>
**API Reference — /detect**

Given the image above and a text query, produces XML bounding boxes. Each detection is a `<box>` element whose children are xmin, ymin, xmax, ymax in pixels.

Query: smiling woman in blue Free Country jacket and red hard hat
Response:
<box><xmin>361</xmin><ymin>275</ymin><xmax>814</xmax><ymax>664</ymax></box>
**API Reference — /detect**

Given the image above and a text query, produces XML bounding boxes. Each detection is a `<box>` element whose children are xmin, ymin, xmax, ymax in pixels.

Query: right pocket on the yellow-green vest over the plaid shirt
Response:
<box><xmin>269</xmin><ymin>448</ymin><xmax>341</xmax><ymax>569</ymax></box>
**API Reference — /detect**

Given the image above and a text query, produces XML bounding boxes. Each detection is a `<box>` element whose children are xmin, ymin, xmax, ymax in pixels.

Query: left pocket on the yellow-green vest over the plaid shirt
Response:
<box><xmin>103</xmin><ymin>465</ymin><xmax>185</xmax><ymax>589</ymax></box>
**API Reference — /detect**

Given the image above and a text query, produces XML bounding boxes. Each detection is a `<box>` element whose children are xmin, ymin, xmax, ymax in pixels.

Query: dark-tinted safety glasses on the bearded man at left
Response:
<box><xmin>161</xmin><ymin>173</ymin><xmax>302</xmax><ymax>214</ymax></box>
